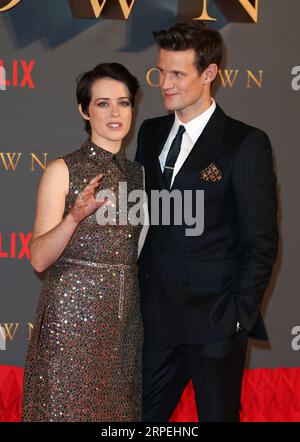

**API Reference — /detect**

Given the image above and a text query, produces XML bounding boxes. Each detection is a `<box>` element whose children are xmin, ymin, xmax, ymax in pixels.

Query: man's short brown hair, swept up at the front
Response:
<box><xmin>153</xmin><ymin>21</ymin><xmax>223</xmax><ymax>74</ymax></box>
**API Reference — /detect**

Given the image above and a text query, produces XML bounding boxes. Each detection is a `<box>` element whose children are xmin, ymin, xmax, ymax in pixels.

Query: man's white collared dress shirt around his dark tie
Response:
<box><xmin>159</xmin><ymin>98</ymin><xmax>216</xmax><ymax>187</ymax></box>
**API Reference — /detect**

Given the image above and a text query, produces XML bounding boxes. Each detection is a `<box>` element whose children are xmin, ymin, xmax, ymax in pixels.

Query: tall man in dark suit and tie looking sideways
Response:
<box><xmin>137</xmin><ymin>23</ymin><xmax>278</xmax><ymax>421</ymax></box>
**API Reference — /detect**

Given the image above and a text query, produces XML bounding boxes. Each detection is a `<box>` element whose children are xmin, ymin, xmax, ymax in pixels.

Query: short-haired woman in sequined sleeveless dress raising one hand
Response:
<box><xmin>23</xmin><ymin>63</ymin><xmax>143</xmax><ymax>422</ymax></box>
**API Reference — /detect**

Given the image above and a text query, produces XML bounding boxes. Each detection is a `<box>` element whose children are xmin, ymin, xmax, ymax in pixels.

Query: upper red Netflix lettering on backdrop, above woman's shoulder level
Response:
<box><xmin>0</xmin><ymin>59</ymin><xmax>36</xmax><ymax>90</ymax></box>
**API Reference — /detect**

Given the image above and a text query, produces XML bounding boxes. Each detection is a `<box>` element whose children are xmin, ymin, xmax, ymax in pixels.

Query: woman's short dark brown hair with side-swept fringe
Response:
<box><xmin>76</xmin><ymin>63</ymin><xmax>139</xmax><ymax>135</ymax></box>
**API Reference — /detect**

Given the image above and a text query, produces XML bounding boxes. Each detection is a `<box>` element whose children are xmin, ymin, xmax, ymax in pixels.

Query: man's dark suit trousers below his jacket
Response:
<box><xmin>143</xmin><ymin>330</ymin><xmax>248</xmax><ymax>422</ymax></box>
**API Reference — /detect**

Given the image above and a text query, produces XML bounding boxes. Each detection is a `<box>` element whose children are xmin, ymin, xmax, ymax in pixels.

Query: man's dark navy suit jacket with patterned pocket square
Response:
<box><xmin>136</xmin><ymin>106</ymin><xmax>278</xmax><ymax>344</ymax></box>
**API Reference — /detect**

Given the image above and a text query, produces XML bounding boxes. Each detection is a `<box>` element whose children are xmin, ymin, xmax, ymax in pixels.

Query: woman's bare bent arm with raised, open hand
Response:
<box><xmin>30</xmin><ymin>159</ymin><xmax>104</xmax><ymax>272</ymax></box>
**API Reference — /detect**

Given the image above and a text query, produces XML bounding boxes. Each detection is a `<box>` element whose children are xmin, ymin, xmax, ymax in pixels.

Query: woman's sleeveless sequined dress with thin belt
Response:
<box><xmin>22</xmin><ymin>141</ymin><xmax>143</xmax><ymax>422</ymax></box>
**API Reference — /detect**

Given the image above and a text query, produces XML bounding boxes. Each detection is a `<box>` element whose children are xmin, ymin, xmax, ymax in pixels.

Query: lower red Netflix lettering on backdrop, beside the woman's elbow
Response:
<box><xmin>0</xmin><ymin>232</ymin><xmax>32</xmax><ymax>259</ymax></box>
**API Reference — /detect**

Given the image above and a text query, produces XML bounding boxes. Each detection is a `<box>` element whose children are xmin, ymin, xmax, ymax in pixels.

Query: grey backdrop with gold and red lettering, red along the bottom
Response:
<box><xmin>0</xmin><ymin>0</ymin><xmax>300</xmax><ymax>422</ymax></box>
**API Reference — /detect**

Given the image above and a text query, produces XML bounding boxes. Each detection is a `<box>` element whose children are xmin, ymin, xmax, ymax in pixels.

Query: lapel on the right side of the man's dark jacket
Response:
<box><xmin>172</xmin><ymin>105</ymin><xmax>226</xmax><ymax>189</ymax></box>
